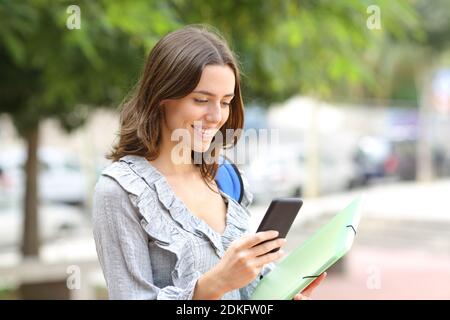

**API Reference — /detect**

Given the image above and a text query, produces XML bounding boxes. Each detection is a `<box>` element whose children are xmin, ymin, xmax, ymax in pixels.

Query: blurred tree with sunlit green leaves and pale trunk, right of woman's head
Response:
<box><xmin>169</xmin><ymin>0</ymin><xmax>418</xmax><ymax>196</ymax></box>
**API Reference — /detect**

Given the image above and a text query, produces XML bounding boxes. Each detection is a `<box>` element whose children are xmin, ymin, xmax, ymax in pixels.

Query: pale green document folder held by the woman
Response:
<box><xmin>251</xmin><ymin>197</ymin><xmax>362</xmax><ymax>300</ymax></box>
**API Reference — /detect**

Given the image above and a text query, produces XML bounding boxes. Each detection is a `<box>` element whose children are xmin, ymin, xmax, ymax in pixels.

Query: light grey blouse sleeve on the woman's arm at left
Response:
<box><xmin>92</xmin><ymin>176</ymin><xmax>201</xmax><ymax>300</ymax></box>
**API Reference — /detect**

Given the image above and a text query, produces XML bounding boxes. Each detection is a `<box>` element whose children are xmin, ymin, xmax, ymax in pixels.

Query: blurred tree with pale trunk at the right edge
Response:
<box><xmin>362</xmin><ymin>0</ymin><xmax>450</xmax><ymax>181</ymax></box>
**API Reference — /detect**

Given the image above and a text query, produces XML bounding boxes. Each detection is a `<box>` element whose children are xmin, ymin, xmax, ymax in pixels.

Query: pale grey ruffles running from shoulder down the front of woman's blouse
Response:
<box><xmin>102</xmin><ymin>155</ymin><xmax>253</xmax><ymax>282</ymax></box>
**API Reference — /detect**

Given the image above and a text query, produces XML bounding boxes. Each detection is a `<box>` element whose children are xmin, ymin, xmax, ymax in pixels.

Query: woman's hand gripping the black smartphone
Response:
<box><xmin>211</xmin><ymin>231</ymin><xmax>286</xmax><ymax>293</ymax></box>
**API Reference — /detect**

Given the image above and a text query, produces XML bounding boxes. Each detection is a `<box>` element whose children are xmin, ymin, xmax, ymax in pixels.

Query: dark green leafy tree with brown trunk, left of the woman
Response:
<box><xmin>0</xmin><ymin>0</ymin><xmax>174</xmax><ymax>257</ymax></box>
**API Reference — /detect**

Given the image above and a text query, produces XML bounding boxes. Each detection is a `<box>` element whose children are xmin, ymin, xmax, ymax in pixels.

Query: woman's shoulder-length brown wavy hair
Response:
<box><xmin>107</xmin><ymin>25</ymin><xmax>244</xmax><ymax>185</ymax></box>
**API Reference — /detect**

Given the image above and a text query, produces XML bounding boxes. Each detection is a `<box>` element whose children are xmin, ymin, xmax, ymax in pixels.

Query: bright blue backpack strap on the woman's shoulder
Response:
<box><xmin>215</xmin><ymin>156</ymin><xmax>244</xmax><ymax>203</ymax></box>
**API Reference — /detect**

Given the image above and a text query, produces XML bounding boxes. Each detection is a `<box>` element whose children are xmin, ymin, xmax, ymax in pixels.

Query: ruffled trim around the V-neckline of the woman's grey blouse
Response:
<box><xmin>102</xmin><ymin>155</ymin><xmax>251</xmax><ymax>257</ymax></box>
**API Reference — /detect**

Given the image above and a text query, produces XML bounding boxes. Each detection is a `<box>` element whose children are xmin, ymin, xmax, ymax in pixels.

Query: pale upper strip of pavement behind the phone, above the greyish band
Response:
<box><xmin>250</xmin><ymin>179</ymin><xmax>450</xmax><ymax>231</ymax></box>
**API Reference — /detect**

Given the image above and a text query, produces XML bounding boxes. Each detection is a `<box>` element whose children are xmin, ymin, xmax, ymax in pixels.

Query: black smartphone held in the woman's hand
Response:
<box><xmin>256</xmin><ymin>198</ymin><xmax>303</xmax><ymax>253</ymax></box>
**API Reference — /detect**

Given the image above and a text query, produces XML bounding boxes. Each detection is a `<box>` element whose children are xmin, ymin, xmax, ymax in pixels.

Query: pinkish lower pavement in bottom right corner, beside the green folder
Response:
<box><xmin>313</xmin><ymin>246</ymin><xmax>450</xmax><ymax>300</ymax></box>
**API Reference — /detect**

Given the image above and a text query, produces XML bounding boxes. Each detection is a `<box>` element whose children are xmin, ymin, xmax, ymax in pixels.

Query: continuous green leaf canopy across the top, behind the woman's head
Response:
<box><xmin>0</xmin><ymin>0</ymin><xmax>428</xmax><ymax>132</ymax></box>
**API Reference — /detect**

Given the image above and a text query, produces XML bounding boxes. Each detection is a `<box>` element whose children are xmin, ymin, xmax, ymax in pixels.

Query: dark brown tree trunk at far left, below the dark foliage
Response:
<box><xmin>22</xmin><ymin>124</ymin><xmax>39</xmax><ymax>258</ymax></box>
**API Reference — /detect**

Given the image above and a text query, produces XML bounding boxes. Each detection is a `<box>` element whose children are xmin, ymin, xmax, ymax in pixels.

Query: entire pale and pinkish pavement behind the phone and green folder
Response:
<box><xmin>250</xmin><ymin>180</ymin><xmax>450</xmax><ymax>300</ymax></box>
